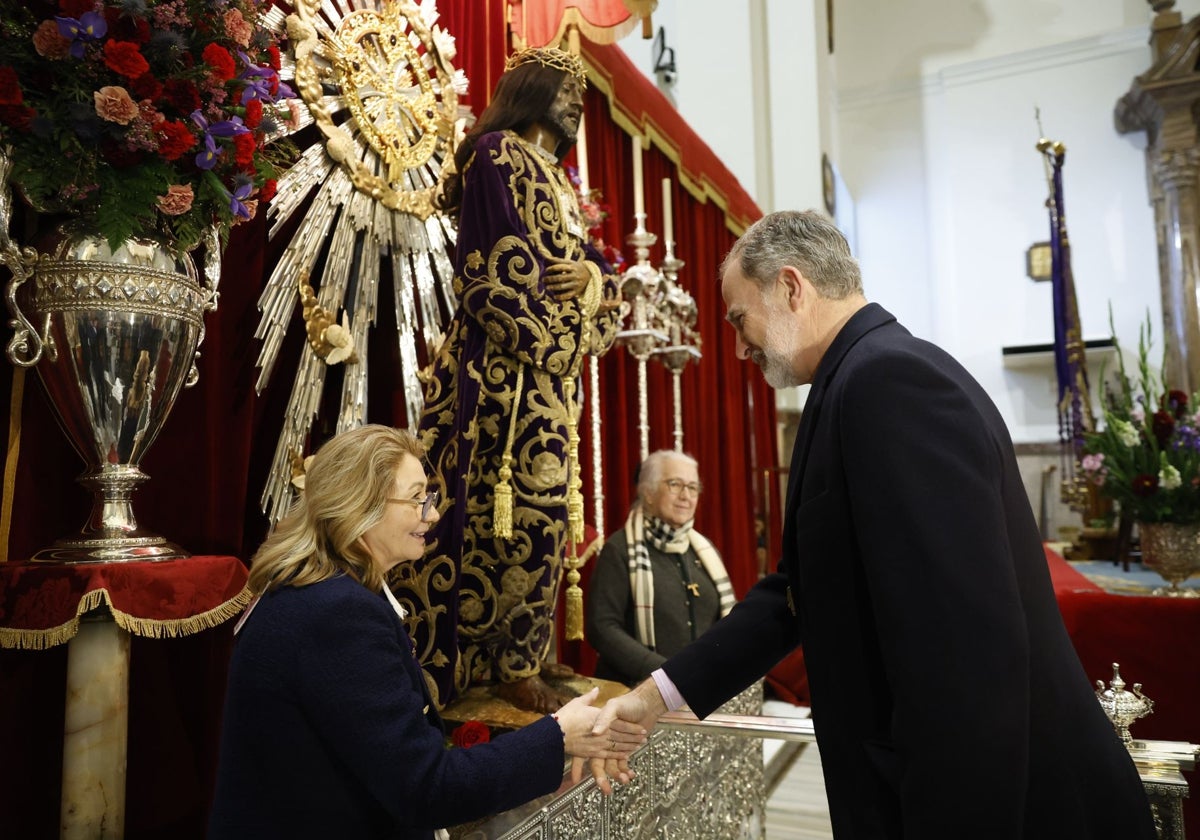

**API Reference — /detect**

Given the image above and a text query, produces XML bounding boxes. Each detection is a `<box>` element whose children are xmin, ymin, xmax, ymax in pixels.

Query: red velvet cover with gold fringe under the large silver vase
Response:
<box><xmin>0</xmin><ymin>556</ymin><xmax>250</xmax><ymax>650</ymax></box>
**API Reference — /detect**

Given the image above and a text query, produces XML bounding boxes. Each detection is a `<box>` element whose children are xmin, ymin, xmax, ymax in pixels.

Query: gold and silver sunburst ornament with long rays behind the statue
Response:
<box><xmin>256</xmin><ymin>0</ymin><xmax>467</xmax><ymax>522</ymax></box>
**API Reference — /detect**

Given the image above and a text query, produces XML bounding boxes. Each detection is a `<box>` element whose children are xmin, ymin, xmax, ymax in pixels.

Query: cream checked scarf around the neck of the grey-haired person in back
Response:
<box><xmin>625</xmin><ymin>502</ymin><xmax>737</xmax><ymax>650</ymax></box>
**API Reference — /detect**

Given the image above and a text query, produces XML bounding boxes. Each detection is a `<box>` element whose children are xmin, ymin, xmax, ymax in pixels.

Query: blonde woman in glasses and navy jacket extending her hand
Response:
<box><xmin>209</xmin><ymin>426</ymin><xmax>644</xmax><ymax>840</ymax></box>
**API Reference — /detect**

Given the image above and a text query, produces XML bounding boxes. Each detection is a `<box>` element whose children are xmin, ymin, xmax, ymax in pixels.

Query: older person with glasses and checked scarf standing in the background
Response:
<box><xmin>583</xmin><ymin>450</ymin><xmax>734</xmax><ymax>685</ymax></box>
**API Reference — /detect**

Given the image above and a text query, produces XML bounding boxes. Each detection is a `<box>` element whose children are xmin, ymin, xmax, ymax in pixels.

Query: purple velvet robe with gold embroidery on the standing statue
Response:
<box><xmin>397</xmin><ymin>131</ymin><xmax>619</xmax><ymax>706</ymax></box>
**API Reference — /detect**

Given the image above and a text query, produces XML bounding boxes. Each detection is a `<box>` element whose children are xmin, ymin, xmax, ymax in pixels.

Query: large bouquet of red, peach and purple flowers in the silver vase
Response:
<box><xmin>0</xmin><ymin>0</ymin><xmax>295</xmax><ymax>251</ymax></box>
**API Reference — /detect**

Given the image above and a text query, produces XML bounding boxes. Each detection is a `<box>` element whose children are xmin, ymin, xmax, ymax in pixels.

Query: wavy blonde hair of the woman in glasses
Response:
<box><xmin>248</xmin><ymin>425</ymin><xmax>425</xmax><ymax>595</ymax></box>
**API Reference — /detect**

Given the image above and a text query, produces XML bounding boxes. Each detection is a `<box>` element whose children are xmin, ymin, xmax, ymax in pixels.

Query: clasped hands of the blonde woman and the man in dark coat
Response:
<box><xmin>554</xmin><ymin>679</ymin><xmax>667</xmax><ymax>793</ymax></box>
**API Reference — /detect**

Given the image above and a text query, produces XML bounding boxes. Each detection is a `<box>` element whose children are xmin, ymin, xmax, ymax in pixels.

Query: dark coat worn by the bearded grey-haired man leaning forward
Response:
<box><xmin>664</xmin><ymin>304</ymin><xmax>1154</xmax><ymax>840</ymax></box>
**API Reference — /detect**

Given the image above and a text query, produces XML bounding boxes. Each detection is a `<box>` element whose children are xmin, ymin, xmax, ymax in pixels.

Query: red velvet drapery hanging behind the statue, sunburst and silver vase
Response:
<box><xmin>0</xmin><ymin>0</ymin><xmax>779</xmax><ymax>839</ymax></box>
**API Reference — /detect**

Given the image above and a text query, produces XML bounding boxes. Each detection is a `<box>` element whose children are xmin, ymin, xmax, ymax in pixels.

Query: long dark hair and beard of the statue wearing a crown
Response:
<box><xmin>437</xmin><ymin>64</ymin><xmax>575</xmax><ymax>216</ymax></box>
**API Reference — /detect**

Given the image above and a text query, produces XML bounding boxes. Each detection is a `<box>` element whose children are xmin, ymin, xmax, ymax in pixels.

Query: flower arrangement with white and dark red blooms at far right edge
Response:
<box><xmin>1080</xmin><ymin>322</ymin><xmax>1200</xmax><ymax>523</ymax></box>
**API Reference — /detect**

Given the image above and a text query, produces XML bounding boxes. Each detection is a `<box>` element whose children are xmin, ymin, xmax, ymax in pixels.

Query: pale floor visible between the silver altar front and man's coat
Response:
<box><xmin>762</xmin><ymin>700</ymin><xmax>833</xmax><ymax>840</ymax></box>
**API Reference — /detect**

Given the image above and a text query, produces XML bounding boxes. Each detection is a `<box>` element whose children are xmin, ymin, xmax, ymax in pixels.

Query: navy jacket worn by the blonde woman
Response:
<box><xmin>209</xmin><ymin>576</ymin><xmax>564</xmax><ymax>840</ymax></box>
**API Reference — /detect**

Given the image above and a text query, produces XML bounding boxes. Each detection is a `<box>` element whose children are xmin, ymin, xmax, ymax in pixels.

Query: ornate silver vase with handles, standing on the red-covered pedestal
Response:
<box><xmin>0</xmin><ymin>155</ymin><xmax>220</xmax><ymax>563</ymax></box>
